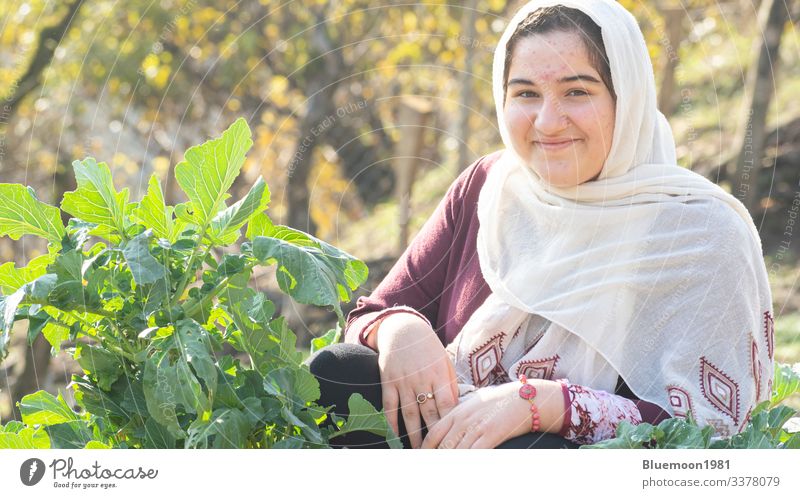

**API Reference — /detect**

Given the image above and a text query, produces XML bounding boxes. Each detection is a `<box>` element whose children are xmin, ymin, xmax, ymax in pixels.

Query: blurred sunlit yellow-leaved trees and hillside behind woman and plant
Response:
<box><xmin>0</xmin><ymin>0</ymin><xmax>800</xmax><ymax>419</ymax></box>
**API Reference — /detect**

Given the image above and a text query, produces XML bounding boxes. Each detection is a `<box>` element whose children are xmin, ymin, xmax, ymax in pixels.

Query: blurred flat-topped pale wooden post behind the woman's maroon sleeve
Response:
<box><xmin>393</xmin><ymin>96</ymin><xmax>433</xmax><ymax>254</ymax></box>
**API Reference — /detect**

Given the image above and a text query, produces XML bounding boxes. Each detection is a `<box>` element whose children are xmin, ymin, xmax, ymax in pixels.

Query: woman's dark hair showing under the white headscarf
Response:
<box><xmin>503</xmin><ymin>5</ymin><xmax>617</xmax><ymax>100</ymax></box>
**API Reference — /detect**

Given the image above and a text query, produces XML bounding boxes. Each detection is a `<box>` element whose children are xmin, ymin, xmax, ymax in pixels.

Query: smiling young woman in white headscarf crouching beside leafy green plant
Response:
<box><xmin>310</xmin><ymin>0</ymin><xmax>773</xmax><ymax>448</ymax></box>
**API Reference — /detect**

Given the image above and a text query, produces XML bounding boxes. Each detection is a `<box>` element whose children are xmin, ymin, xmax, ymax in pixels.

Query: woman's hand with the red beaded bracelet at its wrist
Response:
<box><xmin>422</xmin><ymin>381</ymin><xmax>564</xmax><ymax>449</ymax></box>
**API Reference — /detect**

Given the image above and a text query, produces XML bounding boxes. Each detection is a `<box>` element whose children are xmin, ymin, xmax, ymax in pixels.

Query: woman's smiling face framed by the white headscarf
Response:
<box><xmin>504</xmin><ymin>31</ymin><xmax>615</xmax><ymax>187</ymax></box>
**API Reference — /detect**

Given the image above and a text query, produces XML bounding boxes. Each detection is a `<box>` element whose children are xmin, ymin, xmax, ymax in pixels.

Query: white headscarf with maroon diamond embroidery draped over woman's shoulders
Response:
<box><xmin>447</xmin><ymin>0</ymin><xmax>773</xmax><ymax>435</ymax></box>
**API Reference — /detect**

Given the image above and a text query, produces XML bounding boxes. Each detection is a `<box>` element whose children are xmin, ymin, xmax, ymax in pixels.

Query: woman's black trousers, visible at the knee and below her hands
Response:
<box><xmin>306</xmin><ymin>343</ymin><xmax>578</xmax><ymax>449</ymax></box>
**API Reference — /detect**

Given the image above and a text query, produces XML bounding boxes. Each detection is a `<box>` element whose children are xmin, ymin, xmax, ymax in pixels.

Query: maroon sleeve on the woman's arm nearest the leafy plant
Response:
<box><xmin>345</xmin><ymin>158</ymin><xmax>483</xmax><ymax>344</ymax></box>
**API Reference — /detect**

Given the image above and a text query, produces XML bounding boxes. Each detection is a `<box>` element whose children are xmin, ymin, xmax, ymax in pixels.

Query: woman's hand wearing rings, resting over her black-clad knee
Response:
<box><xmin>376</xmin><ymin>313</ymin><xmax>458</xmax><ymax>448</ymax></box>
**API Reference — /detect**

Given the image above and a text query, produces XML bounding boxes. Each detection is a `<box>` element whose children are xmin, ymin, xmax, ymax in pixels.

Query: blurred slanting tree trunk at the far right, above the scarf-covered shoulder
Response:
<box><xmin>732</xmin><ymin>0</ymin><xmax>792</xmax><ymax>214</ymax></box>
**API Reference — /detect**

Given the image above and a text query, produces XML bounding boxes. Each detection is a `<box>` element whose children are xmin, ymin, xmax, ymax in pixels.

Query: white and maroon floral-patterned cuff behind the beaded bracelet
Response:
<box><xmin>564</xmin><ymin>384</ymin><xmax>642</xmax><ymax>444</ymax></box>
